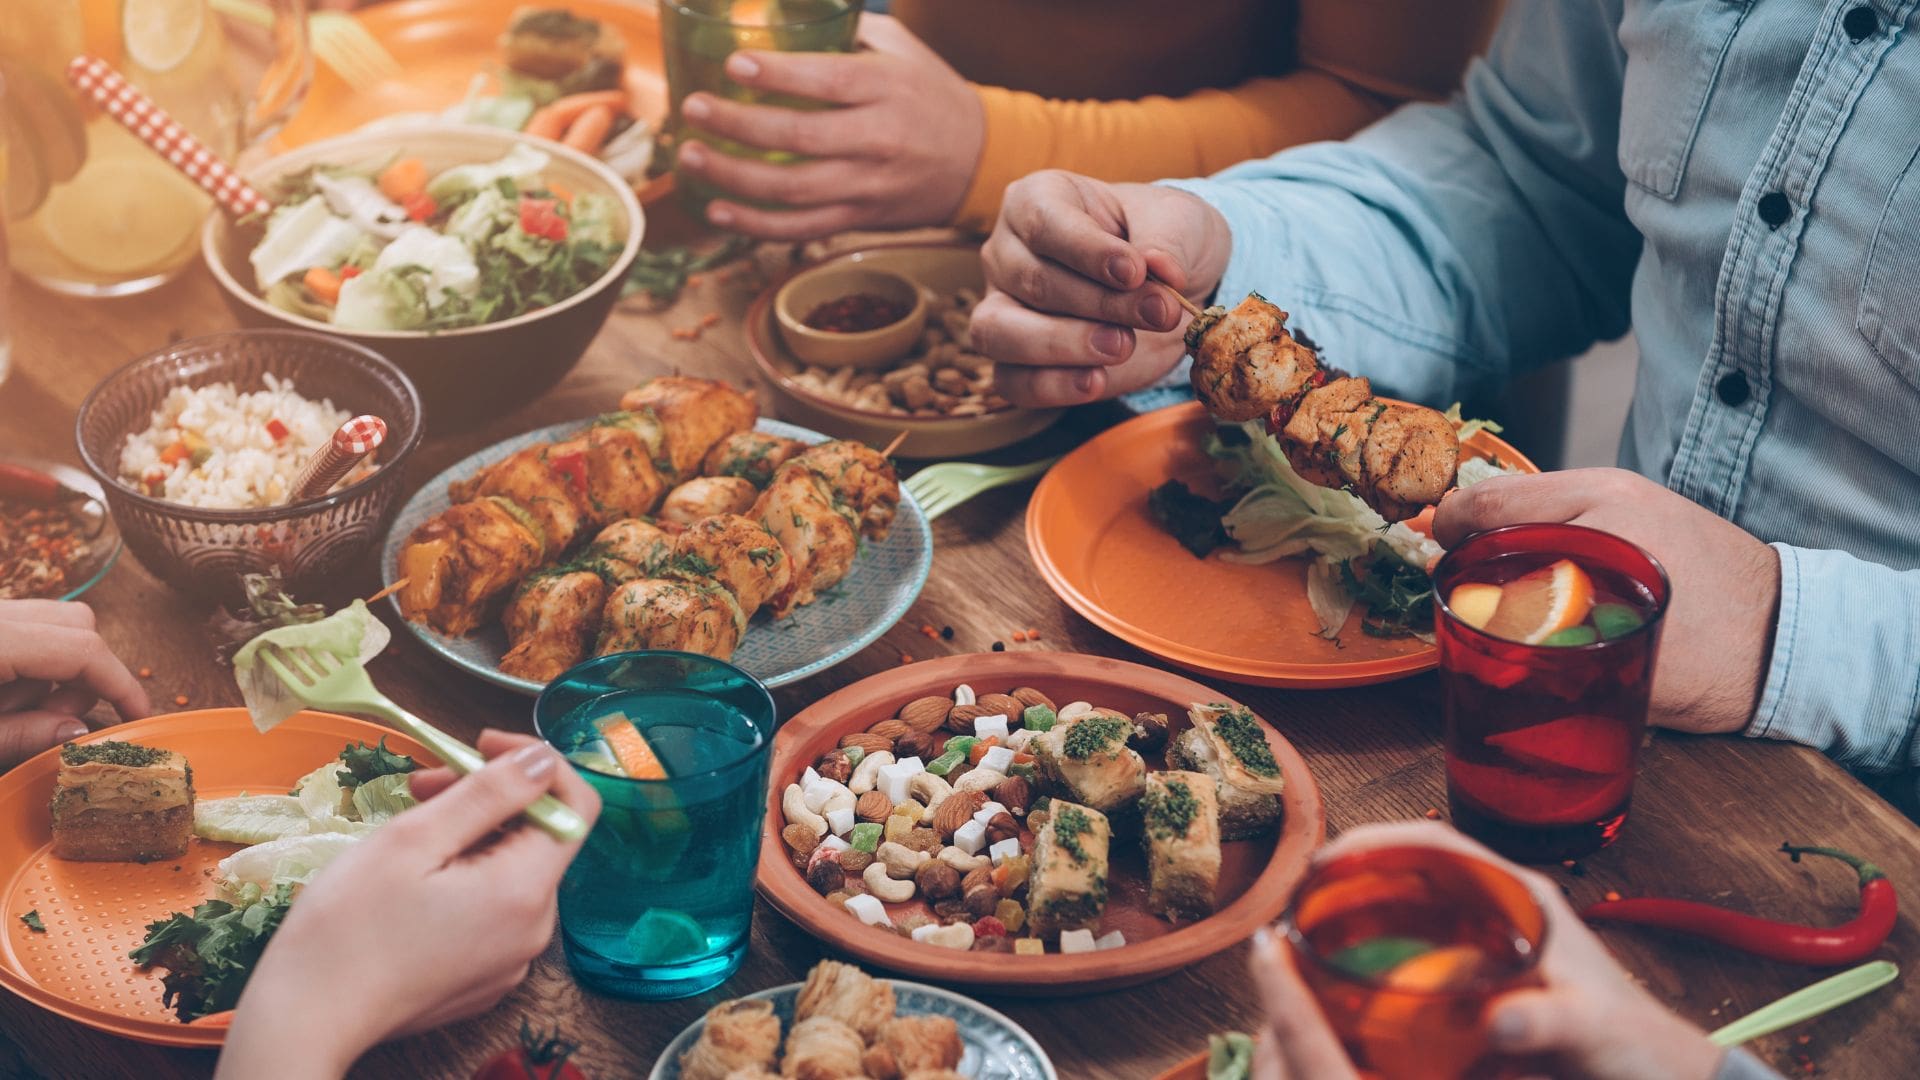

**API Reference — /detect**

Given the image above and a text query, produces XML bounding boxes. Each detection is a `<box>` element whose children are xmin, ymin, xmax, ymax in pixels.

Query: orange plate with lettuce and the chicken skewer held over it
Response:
<box><xmin>1027</xmin><ymin>294</ymin><xmax>1538</xmax><ymax>688</ymax></box>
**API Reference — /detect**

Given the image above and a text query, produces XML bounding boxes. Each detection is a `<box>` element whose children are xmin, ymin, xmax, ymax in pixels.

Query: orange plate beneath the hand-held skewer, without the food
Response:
<box><xmin>1027</xmin><ymin>398</ymin><xmax>1540</xmax><ymax>688</ymax></box>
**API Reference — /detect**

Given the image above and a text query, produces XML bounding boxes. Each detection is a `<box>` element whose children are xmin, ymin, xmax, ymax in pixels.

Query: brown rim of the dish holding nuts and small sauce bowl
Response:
<box><xmin>747</xmin><ymin>244</ymin><xmax>1062</xmax><ymax>461</ymax></box>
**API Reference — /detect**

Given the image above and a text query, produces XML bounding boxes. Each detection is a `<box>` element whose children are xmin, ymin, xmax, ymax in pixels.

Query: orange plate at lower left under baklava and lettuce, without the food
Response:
<box><xmin>0</xmin><ymin>709</ymin><xmax>438</xmax><ymax>1045</ymax></box>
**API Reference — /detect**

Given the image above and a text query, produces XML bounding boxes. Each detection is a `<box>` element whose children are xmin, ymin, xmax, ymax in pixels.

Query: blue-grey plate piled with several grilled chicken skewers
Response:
<box><xmin>382</xmin><ymin>375</ymin><xmax>933</xmax><ymax>694</ymax></box>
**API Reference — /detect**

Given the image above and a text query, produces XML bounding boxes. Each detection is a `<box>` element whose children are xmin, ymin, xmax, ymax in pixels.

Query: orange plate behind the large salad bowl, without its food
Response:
<box><xmin>275</xmin><ymin>0</ymin><xmax>666</xmax><ymax>150</ymax></box>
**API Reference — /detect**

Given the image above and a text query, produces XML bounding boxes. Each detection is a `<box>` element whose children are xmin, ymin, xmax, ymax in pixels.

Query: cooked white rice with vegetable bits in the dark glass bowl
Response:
<box><xmin>119</xmin><ymin>375</ymin><xmax>374</xmax><ymax>509</ymax></box>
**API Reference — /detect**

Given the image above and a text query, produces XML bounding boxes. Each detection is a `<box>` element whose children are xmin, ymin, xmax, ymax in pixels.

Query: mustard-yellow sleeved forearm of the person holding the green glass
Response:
<box><xmin>954</xmin><ymin>69</ymin><xmax>1392</xmax><ymax>231</ymax></box>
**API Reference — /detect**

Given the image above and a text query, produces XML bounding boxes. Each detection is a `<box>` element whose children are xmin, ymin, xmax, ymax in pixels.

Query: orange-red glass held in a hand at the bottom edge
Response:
<box><xmin>1281</xmin><ymin>846</ymin><xmax>1546</xmax><ymax>1080</ymax></box>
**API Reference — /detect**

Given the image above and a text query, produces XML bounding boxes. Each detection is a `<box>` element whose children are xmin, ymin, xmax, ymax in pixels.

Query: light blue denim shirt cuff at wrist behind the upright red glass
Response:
<box><xmin>1747</xmin><ymin>544</ymin><xmax>1920</xmax><ymax>773</ymax></box>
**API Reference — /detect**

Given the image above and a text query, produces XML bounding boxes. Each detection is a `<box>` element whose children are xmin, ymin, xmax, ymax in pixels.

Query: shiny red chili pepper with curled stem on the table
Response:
<box><xmin>1580</xmin><ymin>844</ymin><xmax>1899</xmax><ymax>967</ymax></box>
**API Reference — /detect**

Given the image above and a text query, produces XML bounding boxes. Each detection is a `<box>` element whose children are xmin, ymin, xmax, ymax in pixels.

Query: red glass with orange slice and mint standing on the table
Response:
<box><xmin>1432</xmin><ymin>525</ymin><xmax>1670</xmax><ymax>863</ymax></box>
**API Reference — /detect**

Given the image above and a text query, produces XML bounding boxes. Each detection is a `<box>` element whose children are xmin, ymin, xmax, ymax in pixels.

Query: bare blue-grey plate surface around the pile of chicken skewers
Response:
<box><xmin>380</xmin><ymin>421</ymin><xmax>933</xmax><ymax>696</ymax></box>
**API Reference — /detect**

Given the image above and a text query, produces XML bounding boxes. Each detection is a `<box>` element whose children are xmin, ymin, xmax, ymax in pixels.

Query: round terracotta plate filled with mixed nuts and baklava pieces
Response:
<box><xmin>758</xmin><ymin>653</ymin><xmax>1327</xmax><ymax>995</ymax></box>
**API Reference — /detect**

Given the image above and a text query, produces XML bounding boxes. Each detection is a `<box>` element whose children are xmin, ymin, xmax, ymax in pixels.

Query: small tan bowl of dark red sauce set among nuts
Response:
<box><xmin>774</xmin><ymin>261</ymin><xmax>927</xmax><ymax>367</ymax></box>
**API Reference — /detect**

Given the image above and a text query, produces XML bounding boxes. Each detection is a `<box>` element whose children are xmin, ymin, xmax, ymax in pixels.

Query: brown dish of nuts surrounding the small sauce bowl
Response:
<box><xmin>747</xmin><ymin>244</ymin><xmax>1060</xmax><ymax>459</ymax></box>
